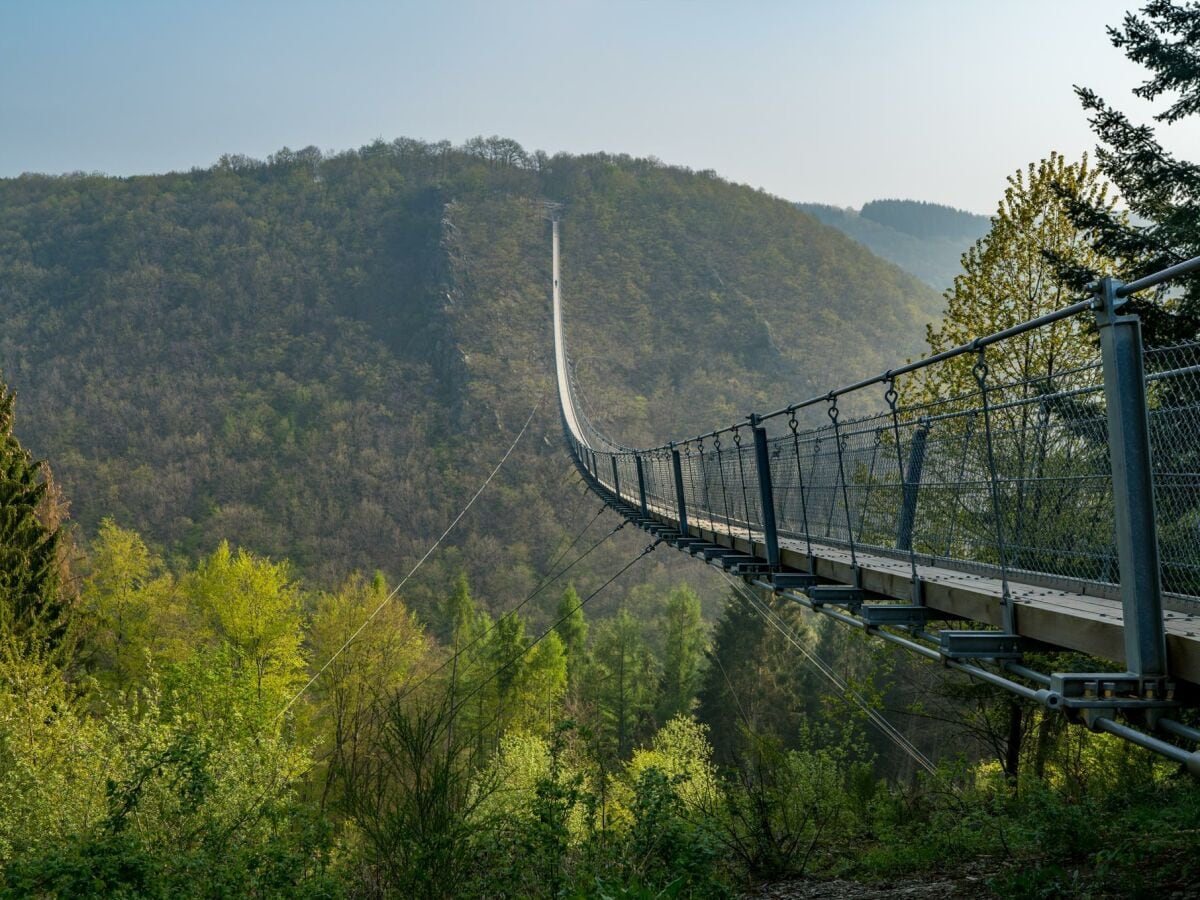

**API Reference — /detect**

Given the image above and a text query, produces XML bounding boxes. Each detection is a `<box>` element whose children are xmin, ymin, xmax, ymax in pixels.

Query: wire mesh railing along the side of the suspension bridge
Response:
<box><xmin>561</xmin><ymin>260</ymin><xmax>1200</xmax><ymax>619</ymax></box>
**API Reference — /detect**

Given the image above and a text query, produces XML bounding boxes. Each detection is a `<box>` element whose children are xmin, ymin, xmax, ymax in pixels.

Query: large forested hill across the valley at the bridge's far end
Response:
<box><xmin>0</xmin><ymin>139</ymin><xmax>941</xmax><ymax>598</ymax></box>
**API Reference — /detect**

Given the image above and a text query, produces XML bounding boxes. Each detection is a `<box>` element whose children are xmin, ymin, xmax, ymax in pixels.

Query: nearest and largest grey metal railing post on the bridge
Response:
<box><xmin>1096</xmin><ymin>277</ymin><xmax>1166</xmax><ymax>678</ymax></box>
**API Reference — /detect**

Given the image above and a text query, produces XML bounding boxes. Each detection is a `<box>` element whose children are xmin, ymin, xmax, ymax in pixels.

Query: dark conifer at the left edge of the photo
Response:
<box><xmin>0</xmin><ymin>382</ymin><xmax>66</xmax><ymax>644</ymax></box>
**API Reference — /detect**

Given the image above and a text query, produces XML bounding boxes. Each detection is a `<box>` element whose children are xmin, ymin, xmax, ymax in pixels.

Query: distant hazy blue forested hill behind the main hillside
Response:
<box><xmin>797</xmin><ymin>200</ymin><xmax>989</xmax><ymax>290</ymax></box>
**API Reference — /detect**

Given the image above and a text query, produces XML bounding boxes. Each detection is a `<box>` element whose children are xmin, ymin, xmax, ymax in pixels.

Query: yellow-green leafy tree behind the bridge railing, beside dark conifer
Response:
<box><xmin>912</xmin><ymin>152</ymin><xmax>1115</xmax><ymax>577</ymax></box>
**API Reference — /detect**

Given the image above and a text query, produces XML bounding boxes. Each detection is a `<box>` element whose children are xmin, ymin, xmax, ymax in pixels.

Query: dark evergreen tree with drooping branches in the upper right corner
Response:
<box><xmin>1060</xmin><ymin>0</ymin><xmax>1200</xmax><ymax>343</ymax></box>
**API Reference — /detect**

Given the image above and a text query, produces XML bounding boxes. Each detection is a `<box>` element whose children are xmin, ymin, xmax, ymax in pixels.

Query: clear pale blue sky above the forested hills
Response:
<box><xmin>0</xmin><ymin>0</ymin><xmax>1200</xmax><ymax>212</ymax></box>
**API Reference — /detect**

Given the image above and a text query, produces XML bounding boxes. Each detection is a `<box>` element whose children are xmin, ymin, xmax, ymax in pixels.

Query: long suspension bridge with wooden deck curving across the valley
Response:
<box><xmin>552</xmin><ymin>216</ymin><xmax>1200</xmax><ymax>776</ymax></box>
